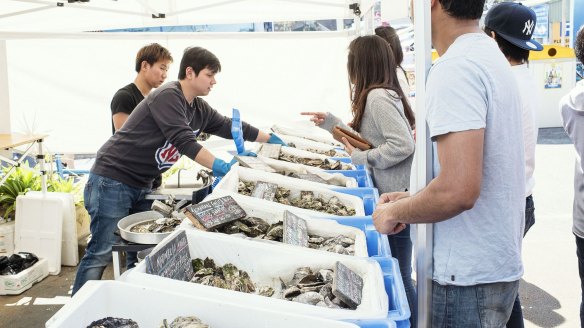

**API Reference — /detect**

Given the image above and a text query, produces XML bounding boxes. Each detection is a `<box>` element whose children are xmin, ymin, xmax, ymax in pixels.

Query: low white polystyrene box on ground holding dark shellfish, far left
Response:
<box><xmin>0</xmin><ymin>254</ymin><xmax>49</xmax><ymax>295</ymax></box>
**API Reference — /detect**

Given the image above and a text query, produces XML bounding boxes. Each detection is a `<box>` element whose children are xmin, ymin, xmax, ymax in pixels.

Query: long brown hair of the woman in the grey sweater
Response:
<box><xmin>347</xmin><ymin>35</ymin><xmax>415</xmax><ymax>132</ymax></box>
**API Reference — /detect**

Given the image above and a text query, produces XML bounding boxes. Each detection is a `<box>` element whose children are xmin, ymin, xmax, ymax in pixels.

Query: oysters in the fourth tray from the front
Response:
<box><xmin>237</xmin><ymin>180</ymin><xmax>356</xmax><ymax>216</ymax></box>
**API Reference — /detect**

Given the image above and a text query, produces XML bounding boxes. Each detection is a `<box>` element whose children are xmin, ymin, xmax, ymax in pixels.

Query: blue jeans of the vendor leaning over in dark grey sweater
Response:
<box><xmin>72</xmin><ymin>174</ymin><xmax>152</xmax><ymax>295</ymax></box>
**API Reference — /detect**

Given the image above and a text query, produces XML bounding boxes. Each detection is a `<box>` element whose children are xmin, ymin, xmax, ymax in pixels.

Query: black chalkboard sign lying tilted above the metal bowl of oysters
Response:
<box><xmin>185</xmin><ymin>196</ymin><xmax>246</xmax><ymax>231</ymax></box>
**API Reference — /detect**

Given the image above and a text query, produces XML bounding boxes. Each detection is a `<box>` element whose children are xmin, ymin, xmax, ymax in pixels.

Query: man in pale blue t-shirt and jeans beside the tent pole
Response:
<box><xmin>373</xmin><ymin>0</ymin><xmax>525</xmax><ymax>327</ymax></box>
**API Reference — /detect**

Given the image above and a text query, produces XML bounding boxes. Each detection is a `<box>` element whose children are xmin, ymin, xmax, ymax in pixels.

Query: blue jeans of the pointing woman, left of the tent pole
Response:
<box><xmin>387</xmin><ymin>224</ymin><xmax>418</xmax><ymax>327</ymax></box>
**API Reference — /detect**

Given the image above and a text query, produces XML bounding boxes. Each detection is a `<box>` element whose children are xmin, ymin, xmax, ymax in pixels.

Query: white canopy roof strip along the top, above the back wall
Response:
<box><xmin>0</xmin><ymin>0</ymin><xmax>373</xmax><ymax>32</ymax></box>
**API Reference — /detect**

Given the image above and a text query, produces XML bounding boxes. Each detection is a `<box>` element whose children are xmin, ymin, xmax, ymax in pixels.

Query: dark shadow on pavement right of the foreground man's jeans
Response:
<box><xmin>519</xmin><ymin>279</ymin><xmax>566</xmax><ymax>328</ymax></box>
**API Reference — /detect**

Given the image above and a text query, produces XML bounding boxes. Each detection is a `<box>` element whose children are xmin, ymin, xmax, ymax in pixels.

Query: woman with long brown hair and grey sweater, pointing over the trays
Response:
<box><xmin>301</xmin><ymin>35</ymin><xmax>417</xmax><ymax>327</ymax></box>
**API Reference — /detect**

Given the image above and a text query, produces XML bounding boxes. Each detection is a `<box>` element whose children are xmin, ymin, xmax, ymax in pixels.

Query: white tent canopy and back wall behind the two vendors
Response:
<box><xmin>0</xmin><ymin>0</ymin><xmax>373</xmax><ymax>153</ymax></box>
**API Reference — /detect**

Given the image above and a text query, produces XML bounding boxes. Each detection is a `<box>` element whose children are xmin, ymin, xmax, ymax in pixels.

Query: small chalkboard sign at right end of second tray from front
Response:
<box><xmin>333</xmin><ymin>261</ymin><xmax>363</xmax><ymax>309</ymax></box>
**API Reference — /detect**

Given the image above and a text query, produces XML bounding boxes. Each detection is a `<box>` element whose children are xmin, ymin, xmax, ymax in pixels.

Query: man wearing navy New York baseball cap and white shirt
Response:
<box><xmin>485</xmin><ymin>2</ymin><xmax>543</xmax><ymax>328</ymax></box>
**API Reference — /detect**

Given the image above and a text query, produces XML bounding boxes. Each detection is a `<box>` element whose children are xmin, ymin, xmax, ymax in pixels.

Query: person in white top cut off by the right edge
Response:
<box><xmin>560</xmin><ymin>27</ymin><xmax>584</xmax><ymax>327</ymax></box>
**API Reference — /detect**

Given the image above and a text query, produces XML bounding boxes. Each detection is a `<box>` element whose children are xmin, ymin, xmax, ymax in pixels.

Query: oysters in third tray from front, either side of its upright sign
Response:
<box><xmin>215</xmin><ymin>216</ymin><xmax>355</xmax><ymax>255</ymax></box>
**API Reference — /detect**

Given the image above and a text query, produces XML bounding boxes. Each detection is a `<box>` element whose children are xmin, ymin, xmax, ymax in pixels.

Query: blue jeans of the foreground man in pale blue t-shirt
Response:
<box><xmin>432</xmin><ymin>280</ymin><xmax>519</xmax><ymax>328</ymax></box>
